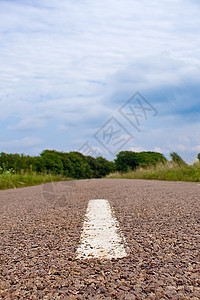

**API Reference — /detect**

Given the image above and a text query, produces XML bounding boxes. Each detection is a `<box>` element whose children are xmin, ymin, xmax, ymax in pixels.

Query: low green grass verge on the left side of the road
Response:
<box><xmin>0</xmin><ymin>172</ymin><xmax>69</xmax><ymax>190</ymax></box>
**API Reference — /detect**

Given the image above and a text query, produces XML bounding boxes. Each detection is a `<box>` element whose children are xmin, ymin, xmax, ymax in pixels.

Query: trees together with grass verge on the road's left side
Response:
<box><xmin>0</xmin><ymin>150</ymin><xmax>115</xmax><ymax>190</ymax></box>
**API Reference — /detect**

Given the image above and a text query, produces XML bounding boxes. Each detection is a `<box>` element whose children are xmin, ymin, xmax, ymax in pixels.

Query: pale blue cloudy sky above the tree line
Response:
<box><xmin>0</xmin><ymin>0</ymin><xmax>200</xmax><ymax>162</ymax></box>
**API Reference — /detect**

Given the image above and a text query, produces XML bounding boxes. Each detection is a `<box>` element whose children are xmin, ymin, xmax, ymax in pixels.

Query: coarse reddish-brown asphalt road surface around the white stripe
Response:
<box><xmin>0</xmin><ymin>179</ymin><xmax>200</xmax><ymax>300</ymax></box>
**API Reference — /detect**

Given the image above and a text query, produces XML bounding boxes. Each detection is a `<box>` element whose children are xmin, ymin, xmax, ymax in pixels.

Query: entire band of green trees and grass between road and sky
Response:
<box><xmin>0</xmin><ymin>150</ymin><xmax>200</xmax><ymax>189</ymax></box>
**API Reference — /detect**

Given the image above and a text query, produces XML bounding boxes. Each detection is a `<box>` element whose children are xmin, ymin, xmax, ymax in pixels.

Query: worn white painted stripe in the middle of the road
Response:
<box><xmin>77</xmin><ymin>199</ymin><xmax>127</xmax><ymax>259</ymax></box>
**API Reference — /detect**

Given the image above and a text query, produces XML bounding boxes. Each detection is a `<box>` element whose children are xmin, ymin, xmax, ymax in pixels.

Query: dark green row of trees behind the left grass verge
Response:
<box><xmin>0</xmin><ymin>150</ymin><xmax>114</xmax><ymax>179</ymax></box>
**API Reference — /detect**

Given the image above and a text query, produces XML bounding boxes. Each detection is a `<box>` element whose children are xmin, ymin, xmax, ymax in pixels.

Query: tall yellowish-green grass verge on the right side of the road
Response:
<box><xmin>107</xmin><ymin>162</ymin><xmax>200</xmax><ymax>182</ymax></box>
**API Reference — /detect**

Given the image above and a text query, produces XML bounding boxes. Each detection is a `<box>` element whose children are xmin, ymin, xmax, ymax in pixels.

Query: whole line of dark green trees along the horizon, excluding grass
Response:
<box><xmin>0</xmin><ymin>150</ymin><xmax>197</xmax><ymax>179</ymax></box>
